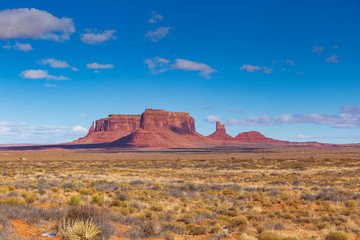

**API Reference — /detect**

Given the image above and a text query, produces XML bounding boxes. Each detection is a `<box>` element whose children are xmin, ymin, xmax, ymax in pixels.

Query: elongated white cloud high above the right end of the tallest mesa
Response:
<box><xmin>172</xmin><ymin>58</ymin><xmax>217</xmax><ymax>79</ymax></box>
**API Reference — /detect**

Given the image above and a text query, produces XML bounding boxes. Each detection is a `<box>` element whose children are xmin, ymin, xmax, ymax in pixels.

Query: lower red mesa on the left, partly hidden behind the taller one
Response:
<box><xmin>72</xmin><ymin>114</ymin><xmax>140</xmax><ymax>144</ymax></box>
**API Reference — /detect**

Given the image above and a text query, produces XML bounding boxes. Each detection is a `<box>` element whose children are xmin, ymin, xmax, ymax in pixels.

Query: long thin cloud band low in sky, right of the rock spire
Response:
<box><xmin>228</xmin><ymin>105</ymin><xmax>360</xmax><ymax>128</ymax></box>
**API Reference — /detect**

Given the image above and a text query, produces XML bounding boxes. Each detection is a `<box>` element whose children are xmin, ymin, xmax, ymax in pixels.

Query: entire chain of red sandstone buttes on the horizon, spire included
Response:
<box><xmin>68</xmin><ymin>109</ymin><xmax>315</xmax><ymax>148</ymax></box>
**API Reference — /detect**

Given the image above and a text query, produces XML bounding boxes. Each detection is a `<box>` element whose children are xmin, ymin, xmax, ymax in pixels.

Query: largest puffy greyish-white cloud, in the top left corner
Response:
<box><xmin>0</xmin><ymin>8</ymin><xmax>75</xmax><ymax>41</ymax></box>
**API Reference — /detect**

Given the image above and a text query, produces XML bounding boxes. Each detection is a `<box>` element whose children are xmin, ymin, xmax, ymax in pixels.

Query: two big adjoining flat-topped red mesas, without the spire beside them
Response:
<box><xmin>72</xmin><ymin>109</ymin><xmax>212</xmax><ymax>148</ymax></box>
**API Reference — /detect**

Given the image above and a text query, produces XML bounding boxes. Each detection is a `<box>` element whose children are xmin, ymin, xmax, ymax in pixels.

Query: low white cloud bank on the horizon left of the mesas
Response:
<box><xmin>0</xmin><ymin>122</ymin><xmax>87</xmax><ymax>143</ymax></box>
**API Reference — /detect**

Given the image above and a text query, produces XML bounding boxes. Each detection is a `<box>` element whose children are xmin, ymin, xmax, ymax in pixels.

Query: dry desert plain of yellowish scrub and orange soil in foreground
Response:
<box><xmin>0</xmin><ymin>149</ymin><xmax>360</xmax><ymax>240</ymax></box>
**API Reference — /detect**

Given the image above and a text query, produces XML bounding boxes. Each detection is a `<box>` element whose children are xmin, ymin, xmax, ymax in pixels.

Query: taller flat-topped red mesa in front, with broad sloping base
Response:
<box><xmin>111</xmin><ymin>109</ymin><xmax>213</xmax><ymax>148</ymax></box>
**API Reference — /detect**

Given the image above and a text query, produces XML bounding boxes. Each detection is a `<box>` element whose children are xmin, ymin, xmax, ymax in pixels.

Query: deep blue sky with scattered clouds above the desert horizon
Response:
<box><xmin>0</xmin><ymin>0</ymin><xmax>360</xmax><ymax>143</ymax></box>
